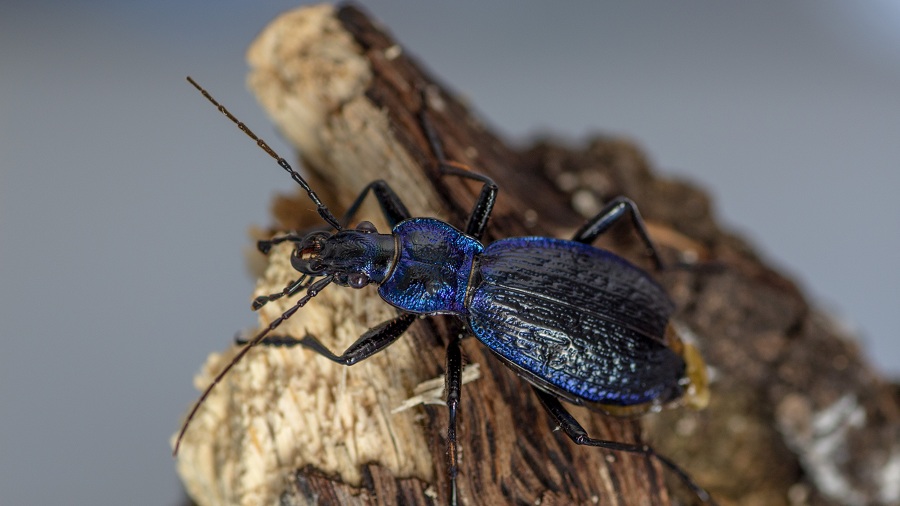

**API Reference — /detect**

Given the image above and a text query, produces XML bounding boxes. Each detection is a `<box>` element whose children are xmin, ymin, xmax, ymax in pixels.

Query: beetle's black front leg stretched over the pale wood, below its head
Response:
<box><xmin>250</xmin><ymin>313</ymin><xmax>418</xmax><ymax>365</ymax></box>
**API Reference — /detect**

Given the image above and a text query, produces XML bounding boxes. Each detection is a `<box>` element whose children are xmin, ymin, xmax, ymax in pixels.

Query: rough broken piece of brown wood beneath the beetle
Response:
<box><xmin>178</xmin><ymin>6</ymin><xmax>900</xmax><ymax>505</ymax></box>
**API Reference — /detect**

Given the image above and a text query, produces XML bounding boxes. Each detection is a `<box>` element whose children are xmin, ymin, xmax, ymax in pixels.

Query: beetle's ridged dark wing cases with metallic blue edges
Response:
<box><xmin>468</xmin><ymin>237</ymin><xmax>684</xmax><ymax>406</ymax></box>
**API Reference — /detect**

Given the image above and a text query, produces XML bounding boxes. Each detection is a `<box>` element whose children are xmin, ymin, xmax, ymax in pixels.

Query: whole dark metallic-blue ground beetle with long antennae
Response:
<box><xmin>175</xmin><ymin>77</ymin><xmax>714</xmax><ymax>505</ymax></box>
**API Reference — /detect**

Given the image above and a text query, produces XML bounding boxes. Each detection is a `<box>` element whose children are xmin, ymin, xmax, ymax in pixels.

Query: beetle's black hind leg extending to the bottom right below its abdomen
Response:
<box><xmin>532</xmin><ymin>387</ymin><xmax>718</xmax><ymax>506</ymax></box>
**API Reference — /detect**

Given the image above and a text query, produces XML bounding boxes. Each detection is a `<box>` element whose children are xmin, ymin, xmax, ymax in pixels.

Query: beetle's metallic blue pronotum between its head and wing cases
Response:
<box><xmin>378</xmin><ymin>218</ymin><xmax>484</xmax><ymax>316</ymax></box>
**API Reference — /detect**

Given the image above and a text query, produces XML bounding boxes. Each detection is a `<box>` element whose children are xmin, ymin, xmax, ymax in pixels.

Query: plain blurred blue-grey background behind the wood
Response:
<box><xmin>0</xmin><ymin>0</ymin><xmax>900</xmax><ymax>505</ymax></box>
